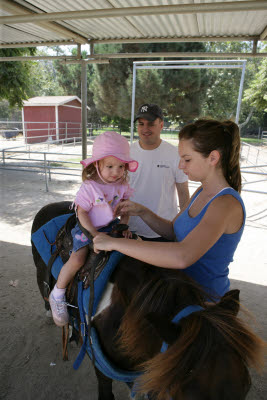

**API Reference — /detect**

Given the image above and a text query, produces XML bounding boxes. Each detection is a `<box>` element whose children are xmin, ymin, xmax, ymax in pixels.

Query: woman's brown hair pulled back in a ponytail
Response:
<box><xmin>179</xmin><ymin>119</ymin><xmax>241</xmax><ymax>193</ymax></box>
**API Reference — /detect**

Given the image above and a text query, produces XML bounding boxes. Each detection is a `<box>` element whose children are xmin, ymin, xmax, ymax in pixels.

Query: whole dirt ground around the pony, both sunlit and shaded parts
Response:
<box><xmin>0</xmin><ymin>163</ymin><xmax>267</xmax><ymax>400</ymax></box>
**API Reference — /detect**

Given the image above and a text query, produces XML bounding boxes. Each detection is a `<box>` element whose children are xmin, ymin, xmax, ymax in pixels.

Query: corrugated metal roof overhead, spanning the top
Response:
<box><xmin>0</xmin><ymin>0</ymin><xmax>267</xmax><ymax>48</ymax></box>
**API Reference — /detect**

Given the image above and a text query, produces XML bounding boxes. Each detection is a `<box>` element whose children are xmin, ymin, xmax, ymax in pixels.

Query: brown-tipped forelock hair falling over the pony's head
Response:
<box><xmin>136</xmin><ymin>305</ymin><xmax>266</xmax><ymax>400</ymax></box>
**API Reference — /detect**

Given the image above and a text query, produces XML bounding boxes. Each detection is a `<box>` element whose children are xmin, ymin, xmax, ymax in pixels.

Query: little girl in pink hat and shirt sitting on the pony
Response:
<box><xmin>49</xmin><ymin>132</ymin><xmax>138</xmax><ymax>326</ymax></box>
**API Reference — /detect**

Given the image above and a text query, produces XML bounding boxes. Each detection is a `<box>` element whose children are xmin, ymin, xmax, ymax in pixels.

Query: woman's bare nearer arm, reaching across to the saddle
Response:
<box><xmin>94</xmin><ymin>196</ymin><xmax>242</xmax><ymax>269</ymax></box>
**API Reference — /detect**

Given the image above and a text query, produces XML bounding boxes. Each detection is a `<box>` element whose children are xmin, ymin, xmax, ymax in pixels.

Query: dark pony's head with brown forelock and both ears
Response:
<box><xmin>136</xmin><ymin>290</ymin><xmax>266</xmax><ymax>400</ymax></box>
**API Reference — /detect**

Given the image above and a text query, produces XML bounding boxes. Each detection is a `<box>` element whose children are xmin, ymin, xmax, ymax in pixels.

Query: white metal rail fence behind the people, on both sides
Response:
<box><xmin>0</xmin><ymin>138</ymin><xmax>267</xmax><ymax>194</ymax></box>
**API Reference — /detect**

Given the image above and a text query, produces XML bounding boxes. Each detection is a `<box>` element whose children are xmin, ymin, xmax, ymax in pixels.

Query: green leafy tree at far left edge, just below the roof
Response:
<box><xmin>0</xmin><ymin>48</ymin><xmax>36</xmax><ymax>107</ymax></box>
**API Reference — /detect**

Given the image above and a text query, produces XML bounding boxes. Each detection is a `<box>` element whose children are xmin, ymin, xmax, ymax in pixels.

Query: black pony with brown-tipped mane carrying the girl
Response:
<box><xmin>32</xmin><ymin>202</ymin><xmax>264</xmax><ymax>400</ymax></box>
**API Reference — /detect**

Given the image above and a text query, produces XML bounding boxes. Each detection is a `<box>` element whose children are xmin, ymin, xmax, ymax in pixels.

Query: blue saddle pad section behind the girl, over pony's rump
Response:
<box><xmin>31</xmin><ymin>214</ymin><xmax>71</xmax><ymax>279</ymax></box>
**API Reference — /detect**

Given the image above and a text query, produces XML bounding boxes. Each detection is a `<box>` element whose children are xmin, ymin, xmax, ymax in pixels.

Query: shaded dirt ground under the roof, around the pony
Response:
<box><xmin>0</xmin><ymin>242</ymin><xmax>267</xmax><ymax>400</ymax></box>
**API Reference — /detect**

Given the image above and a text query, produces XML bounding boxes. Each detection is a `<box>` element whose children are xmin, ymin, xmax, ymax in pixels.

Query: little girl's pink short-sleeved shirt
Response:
<box><xmin>74</xmin><ymin>180</ymin><xmax>134</xmax><ymax>228</ymax></box>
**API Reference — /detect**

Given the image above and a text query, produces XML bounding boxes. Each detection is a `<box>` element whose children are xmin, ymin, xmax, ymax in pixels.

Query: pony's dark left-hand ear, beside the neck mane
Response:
<box><xmin>145</xmin><ymin>313</ymin><xmax>181</xmax><ymax>344</ymax></box>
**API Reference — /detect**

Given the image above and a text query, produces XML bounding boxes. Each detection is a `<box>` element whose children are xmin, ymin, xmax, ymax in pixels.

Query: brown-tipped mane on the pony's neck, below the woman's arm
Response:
<box><xmin>117</xmin><ymin>270</ymin><xmax>206</xmax><ymax>365</ymax></box>
